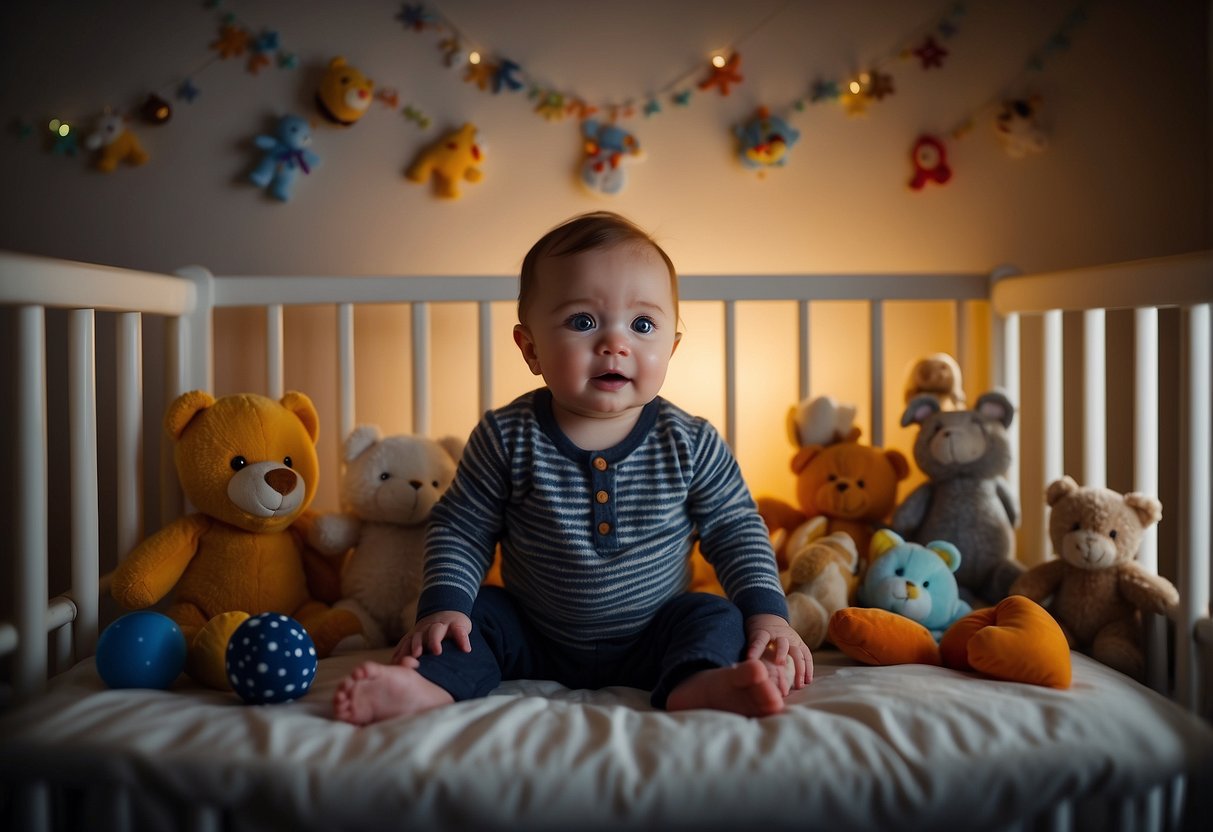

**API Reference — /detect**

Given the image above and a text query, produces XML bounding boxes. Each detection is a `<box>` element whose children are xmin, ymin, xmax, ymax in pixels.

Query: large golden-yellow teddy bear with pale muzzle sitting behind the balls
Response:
<box><xmin>110</xmin><ymin>391</ymin><xmax>361</xmax><ymax>690</ymax></box>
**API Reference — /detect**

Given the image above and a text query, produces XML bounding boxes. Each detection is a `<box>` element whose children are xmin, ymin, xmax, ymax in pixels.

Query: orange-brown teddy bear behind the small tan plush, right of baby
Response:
<box><xmin>758</xmin><ymin>409</ymin><xmax>910</xmax><ymax>575</ymax></box>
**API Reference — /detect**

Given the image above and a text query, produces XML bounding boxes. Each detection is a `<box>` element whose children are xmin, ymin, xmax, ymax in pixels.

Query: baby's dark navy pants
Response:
<box><xmin>418</xmin><ymin>587</ymin><xmax>746</xmax><ymax>708</ymax></box>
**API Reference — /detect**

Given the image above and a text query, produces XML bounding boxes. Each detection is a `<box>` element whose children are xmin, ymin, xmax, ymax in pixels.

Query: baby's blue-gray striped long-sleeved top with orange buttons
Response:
<box><xmin>417</xmin><ymin>388</ymin><xmax>787</xmax><ymax>651</ymax></box>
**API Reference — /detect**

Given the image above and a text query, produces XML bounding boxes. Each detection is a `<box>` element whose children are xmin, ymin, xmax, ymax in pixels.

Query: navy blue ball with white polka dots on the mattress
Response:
<box><xmin>227</xmin><ymin>612</ymin><xmax>317</xmax><ymax>705</ymax></box>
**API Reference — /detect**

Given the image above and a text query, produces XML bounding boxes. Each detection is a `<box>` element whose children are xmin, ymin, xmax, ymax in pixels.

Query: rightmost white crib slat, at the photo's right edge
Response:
<box><xmin>1175</xmin><ymin>303</ymin><xmax>1213</xmax><ymax>710</ymax></box>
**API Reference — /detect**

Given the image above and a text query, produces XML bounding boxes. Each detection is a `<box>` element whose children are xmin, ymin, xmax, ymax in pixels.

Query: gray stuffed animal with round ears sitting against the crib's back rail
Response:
<box><xmin>892</xmin><ymin>391</ymin><xmax>1024</xmax><ymax>605</ymax></box>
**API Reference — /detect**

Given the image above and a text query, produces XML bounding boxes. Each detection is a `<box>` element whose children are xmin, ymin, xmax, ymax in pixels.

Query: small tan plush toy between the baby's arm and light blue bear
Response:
<box><xmin>771</xmin><ymin>517</ymin><xmax>859</xmax><ymax>649</ymax></box>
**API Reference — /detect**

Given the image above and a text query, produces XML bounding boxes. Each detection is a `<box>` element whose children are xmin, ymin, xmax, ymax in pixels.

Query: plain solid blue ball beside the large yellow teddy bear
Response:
<box><xmin>96</xmin><ymin>610</ymin><xmax>186</xmax><ymax>690</ymax></box>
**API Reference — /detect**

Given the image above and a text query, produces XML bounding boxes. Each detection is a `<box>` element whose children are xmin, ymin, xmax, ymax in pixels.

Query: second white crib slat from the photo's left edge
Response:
<box><xmin>68</xmin><ymin>309</ymin><xmax>101</xmax><ymax>659</ymax></box>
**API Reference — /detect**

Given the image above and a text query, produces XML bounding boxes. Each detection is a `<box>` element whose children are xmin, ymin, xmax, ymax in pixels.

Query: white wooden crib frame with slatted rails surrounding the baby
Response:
<box><xmin>0</xmin><ymin>252</ymin><xmax>1213</xmax><ymax>828</ymax></box>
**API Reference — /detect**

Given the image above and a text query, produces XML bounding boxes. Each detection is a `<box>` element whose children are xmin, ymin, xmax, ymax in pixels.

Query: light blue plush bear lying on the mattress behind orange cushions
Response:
<box><xmin>858</xmin><ymin>529</ymin><xmax>973</xmax><ymax>642</ymax></box>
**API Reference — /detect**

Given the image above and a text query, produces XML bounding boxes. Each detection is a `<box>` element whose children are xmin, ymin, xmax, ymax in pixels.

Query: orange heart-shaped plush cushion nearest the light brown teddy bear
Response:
<box><xmin>939</xmin><ymin>595</ymin><xmax>1071</xmax><ymax>688</ymax></box>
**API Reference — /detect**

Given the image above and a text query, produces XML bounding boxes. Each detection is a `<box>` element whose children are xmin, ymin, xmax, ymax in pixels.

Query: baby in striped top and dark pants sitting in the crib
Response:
<box><xmin>334</xmin><ymin>212</ymin><xmax>813</xmax><ymax>724</ymax></box>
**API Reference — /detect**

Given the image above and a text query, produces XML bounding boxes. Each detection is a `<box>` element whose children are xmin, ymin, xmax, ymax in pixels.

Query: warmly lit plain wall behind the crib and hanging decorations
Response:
<box><xmin>0</xmin><ymin>0</ymin><xmax>1213</xmax><ymax>577</ymax></box>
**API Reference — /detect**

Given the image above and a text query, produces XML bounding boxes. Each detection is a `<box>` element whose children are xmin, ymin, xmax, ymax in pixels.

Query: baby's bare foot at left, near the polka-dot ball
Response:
<box><xmin>332</xmin><ymin>656</ymin><xmax>455</xmax><ymax>725</ymax></box>
